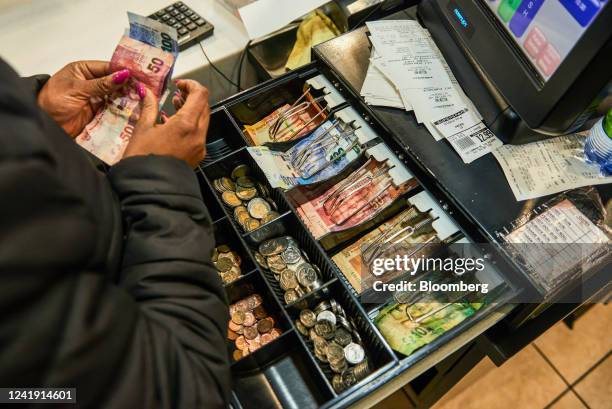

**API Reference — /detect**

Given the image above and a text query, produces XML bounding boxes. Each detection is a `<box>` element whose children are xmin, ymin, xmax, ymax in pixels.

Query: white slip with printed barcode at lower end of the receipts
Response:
<box><xmin>446</xmin><ymin>122</ymin><xmax>504</xmax><ymax>163</ymax></box>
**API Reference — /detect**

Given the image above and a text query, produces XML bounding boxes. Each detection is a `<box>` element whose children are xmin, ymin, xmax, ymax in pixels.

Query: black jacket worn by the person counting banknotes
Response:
<box><xmin>0</xmin><ymin>59</ymin><xmax>230</xmax><ymax>409</ymax></box>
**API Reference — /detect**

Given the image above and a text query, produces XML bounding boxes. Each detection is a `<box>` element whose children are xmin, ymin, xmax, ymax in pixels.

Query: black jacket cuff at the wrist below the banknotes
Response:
<box><xmin>109</xmin><ymin>155</ymin><xmax>202</xmax><ymax>200</ymax></box>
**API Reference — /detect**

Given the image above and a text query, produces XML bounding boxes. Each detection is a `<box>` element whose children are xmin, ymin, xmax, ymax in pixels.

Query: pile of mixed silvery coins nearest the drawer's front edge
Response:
<box><xmin>295</xmin><ymin>299</ymin><xmax>370</xmax><ymax>393</ymax></box>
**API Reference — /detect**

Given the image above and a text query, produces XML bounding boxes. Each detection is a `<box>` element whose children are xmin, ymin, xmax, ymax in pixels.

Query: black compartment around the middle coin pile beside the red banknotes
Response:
<box><xmin>247</xmin><ymin>212</ymin><xmax>337</xmax><ymax>305</ymax></box>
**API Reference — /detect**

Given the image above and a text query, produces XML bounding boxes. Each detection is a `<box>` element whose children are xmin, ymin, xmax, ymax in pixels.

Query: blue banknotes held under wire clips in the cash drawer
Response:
<box><xmin>247</xmin><ymin>121</ymin><xmax>363</xmax><ymax>190</ymax></box>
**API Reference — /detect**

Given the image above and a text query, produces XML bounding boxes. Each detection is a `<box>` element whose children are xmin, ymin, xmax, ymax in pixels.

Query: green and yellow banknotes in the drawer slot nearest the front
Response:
<box><xmin>374</xmin><ymin>294</ymin><xmax>483</xmax><ymax>355</ymax></box>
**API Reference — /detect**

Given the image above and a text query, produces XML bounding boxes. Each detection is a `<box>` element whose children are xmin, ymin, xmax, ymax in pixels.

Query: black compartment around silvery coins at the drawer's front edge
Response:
<box><xmin>287</xmin><ymin>281</ymin><xmax>397</xmax><ymax>395</ymax></box>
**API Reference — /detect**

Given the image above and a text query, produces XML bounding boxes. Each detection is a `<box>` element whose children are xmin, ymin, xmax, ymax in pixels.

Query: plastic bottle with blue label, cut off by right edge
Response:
<box><xmin>584</xmin><ymin>109</ymin><xmax>612</xmax><ymax>176</ymax></box>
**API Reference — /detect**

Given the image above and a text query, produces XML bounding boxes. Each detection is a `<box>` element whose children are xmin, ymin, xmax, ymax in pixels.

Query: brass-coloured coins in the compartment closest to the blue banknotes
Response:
<box><xmin>213</xmin><ymin>165</ymin><xmax>280</xmax><ymax>232</ymax></box>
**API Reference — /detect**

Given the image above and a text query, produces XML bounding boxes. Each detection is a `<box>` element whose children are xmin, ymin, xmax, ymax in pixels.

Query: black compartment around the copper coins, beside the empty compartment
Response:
<box><xmin>225</xmin><ymin>273</ymin><xmax>293</xmax><ymax>360</ymax></box>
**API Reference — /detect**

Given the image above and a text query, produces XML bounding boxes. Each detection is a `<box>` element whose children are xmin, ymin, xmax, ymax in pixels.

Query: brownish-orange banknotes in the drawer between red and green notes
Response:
<box><xmin>332</xmin><ymin>206</ymin><xmax>439</xmax><ymax>294</ymax></box>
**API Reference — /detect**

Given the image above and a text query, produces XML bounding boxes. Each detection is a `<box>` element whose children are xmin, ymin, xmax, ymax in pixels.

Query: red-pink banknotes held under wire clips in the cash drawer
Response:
<box><xmin>288</xmin><ymin>158</ymin><xmax>417</xmax><ymax>240</ymax></box>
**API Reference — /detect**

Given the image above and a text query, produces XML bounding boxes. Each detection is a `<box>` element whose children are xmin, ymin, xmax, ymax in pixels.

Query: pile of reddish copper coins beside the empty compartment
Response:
<box><xmin>227</xmin><ymin>294</ymin><xmax>281</xmax><ymax>361</ymax></box>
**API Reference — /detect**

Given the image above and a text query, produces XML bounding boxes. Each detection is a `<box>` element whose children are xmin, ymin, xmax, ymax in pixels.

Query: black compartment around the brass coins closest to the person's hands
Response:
<box><xmin>200</xmin><ymin>148</ymin><xmax>289</xmax><ymax>236</ymax></box>
